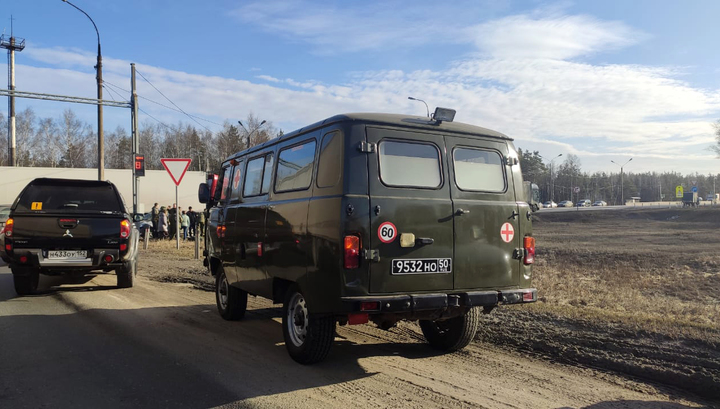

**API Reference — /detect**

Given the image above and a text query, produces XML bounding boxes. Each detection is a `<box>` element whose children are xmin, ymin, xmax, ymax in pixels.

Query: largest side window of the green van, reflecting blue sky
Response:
<box><xmin>275</xmin><ymin>139</ymin><xmax>315</xmax><ymax>193</ymax></box>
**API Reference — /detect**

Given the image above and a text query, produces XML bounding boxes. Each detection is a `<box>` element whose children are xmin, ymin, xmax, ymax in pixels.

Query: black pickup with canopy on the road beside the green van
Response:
<box><xmin>0</xmin><ymin>178</ymin><xmax>139</xmax><ymax>295</ymax></box>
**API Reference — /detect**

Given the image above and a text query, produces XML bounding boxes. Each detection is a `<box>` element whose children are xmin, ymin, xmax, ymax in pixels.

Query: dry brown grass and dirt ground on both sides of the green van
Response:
<box><xmin>141</xmin><ymin>208</ymin><xmax>720</xmax><ymax>402</ymax></box>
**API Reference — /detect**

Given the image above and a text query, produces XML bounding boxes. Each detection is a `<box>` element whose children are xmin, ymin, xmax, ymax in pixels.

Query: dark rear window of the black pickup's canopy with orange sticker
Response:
<box><xmin>15</xmin><ymin>185</ymin><xmax>125</xmax><ymax>213</ymax></box>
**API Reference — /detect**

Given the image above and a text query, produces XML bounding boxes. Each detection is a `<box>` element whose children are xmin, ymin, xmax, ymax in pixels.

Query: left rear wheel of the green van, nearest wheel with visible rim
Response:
<box><xmin>282</xmin><ymin>285</ymin><xmax>335</xmax><ymax>365</ymax></box>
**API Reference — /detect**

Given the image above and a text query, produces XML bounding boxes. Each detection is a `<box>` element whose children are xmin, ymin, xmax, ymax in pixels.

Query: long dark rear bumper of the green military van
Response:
<box><xmin>342</xmin><ymin>288</ymin><xmax>537</xmax><ymax>313</ymax></box>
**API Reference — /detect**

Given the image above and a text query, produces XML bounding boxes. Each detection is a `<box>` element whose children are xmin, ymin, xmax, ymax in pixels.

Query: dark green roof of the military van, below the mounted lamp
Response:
<box><xmin>228</xmin><ymin>112</ymin><xmax>512</xmax><ymax>159</ymax></box>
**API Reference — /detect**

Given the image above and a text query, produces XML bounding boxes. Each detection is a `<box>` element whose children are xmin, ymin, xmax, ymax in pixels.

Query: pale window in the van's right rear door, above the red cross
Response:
<box><xmin>453</xmin><ymin>148</ymin><xmax>505</xmax><ymax>192</ymax></box>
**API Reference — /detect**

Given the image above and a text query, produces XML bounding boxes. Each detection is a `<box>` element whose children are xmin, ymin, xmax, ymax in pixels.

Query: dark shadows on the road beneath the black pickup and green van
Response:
<box><xmin>0</xmin><ymin>274</ymin><xmax>448</xmax><ymax>408</ymax></box>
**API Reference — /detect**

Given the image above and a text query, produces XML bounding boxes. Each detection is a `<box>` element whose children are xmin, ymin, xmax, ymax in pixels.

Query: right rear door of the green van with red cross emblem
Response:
<box><xmin>445</xmin><ymin>136</ymin><xmax>525</xmax><ymax>290</ymax></box>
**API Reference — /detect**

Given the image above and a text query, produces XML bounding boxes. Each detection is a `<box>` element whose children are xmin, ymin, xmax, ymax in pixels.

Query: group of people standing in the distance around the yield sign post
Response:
<box><xmin>152</xmin><ymin>203</ymin><xmax>205</xmax><ymax>240</ymax></box>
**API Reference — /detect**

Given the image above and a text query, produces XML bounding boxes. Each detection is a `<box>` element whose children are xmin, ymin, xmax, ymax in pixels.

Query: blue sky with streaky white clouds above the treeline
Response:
<box><xmin>0</xmin><ymin>0</ymin><xmax>720</xmax><ymax>174</ymax></box>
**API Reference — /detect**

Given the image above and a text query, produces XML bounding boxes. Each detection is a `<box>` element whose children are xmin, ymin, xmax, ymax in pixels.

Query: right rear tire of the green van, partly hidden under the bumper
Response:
<box><xmin>419</xmin><ymin>307</ymin><xmax>480</xmax><ymax>352</ymax></box>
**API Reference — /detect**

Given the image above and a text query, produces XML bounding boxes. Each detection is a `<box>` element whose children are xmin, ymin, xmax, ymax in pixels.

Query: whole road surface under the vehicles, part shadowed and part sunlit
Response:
<box><xmin>0</xmin><ymin>267</ymin><xmax>708</xmax><ymax>409</ymax></box>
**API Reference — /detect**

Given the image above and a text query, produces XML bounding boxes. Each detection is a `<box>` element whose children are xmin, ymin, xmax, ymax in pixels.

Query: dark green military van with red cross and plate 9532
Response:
<box><xmin>199</xmin><ymin>108</ymin><xmax>537</xmax><ymax>364</ymax></box>
